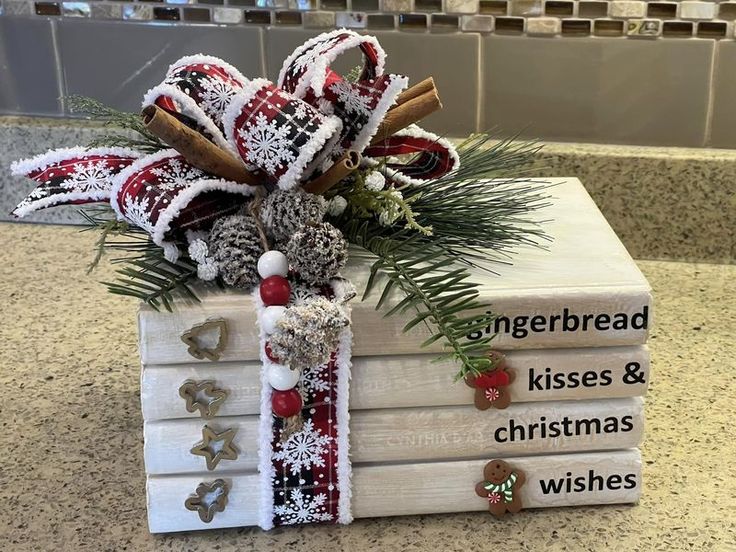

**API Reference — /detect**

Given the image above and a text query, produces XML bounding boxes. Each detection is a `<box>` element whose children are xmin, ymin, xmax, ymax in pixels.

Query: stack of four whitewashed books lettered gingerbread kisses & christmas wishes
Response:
<box><xmin>139</xmin><ymin>179</ymin><xmax>652</xmax><ymax>532</ymax></box>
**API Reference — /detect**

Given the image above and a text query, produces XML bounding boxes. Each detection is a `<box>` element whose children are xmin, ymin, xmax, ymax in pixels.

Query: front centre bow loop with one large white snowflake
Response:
<box><xmin>222</xmin><ymin>79</ymin><xmax>342</xmax><ymax>190</ymax></box>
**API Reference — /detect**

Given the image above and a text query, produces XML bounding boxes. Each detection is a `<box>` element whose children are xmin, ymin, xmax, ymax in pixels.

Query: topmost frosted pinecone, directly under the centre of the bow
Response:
<box><xmin>261</xmin><ymin>190</ymin><xmax>327</xmax><ymax>241</ymax></box>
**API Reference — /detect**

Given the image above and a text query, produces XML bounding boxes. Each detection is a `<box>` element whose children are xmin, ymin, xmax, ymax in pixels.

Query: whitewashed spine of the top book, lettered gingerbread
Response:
<box><xmin>139</xmin><ymin>287</ymin><xmax>652</xmax><ymax>364</ymax></box>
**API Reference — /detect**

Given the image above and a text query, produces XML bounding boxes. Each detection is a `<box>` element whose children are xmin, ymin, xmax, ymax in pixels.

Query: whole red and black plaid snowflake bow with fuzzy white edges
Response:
<box><xmin>12</xmin><ymin>29</ymin><xmax>459</xmax><ymax>260</ymax></box>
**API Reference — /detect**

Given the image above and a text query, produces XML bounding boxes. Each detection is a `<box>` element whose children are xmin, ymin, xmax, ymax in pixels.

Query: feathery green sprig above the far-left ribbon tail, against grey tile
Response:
<box><xmin>65</xmin><ymin>95</ymin><xmax>168</xmax><ymax>153</ymax></box>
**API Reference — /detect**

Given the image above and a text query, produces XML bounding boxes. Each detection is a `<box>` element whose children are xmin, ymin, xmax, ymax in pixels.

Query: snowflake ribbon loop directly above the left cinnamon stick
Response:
<box><xmin>142</xmin><ymin>54</ymin><xmax>250</xmax><ymax>153</ymax></box>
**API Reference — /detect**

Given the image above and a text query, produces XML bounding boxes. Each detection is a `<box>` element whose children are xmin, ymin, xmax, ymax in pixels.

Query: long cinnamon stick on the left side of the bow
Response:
<box><xmin>141</xmin><ymin>105</ymin><xmax>261</xmax><ymax>186</ymax></box>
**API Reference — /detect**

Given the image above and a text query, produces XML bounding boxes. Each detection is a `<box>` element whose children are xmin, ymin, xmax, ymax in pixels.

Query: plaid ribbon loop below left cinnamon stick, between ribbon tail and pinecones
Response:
<box><xmin>110</xmin><ymin>150</ymin><xmax>256</xmax><ymax>249</ymax></box>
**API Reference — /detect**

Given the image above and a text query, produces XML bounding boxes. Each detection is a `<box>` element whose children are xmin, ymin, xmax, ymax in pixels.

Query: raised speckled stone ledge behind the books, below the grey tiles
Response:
<box><xmin>0</xmin><ymin>117</ymin><xmax>736</xmax><ymax>263</ymax></box>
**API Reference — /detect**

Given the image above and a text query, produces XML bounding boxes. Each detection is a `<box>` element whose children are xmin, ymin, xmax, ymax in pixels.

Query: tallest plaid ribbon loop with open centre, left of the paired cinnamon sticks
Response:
<box><xmin>278</xmin><ymin>29</ymin><xmax>409</xmax><ymax>155</ymax></box>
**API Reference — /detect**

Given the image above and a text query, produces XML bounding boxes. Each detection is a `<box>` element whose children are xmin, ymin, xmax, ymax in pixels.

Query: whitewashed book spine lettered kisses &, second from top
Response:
<box><xmin>141</xmin><ymin>345</ymin><xmax>649</xmax><ymax>421</ymax></box>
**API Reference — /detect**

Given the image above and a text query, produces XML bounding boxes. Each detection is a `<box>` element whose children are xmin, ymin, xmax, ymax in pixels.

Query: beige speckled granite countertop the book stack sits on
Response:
<box><xmin>0</xmin><ymin>224</ymin><xmax>736</xmax><ymax>552</ymax></box>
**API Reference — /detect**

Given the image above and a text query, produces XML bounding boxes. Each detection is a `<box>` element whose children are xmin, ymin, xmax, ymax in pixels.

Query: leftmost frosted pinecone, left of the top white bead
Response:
<box><xmin>207</xmin><ymin>215</ymin><xmax>263</xmax><ymax>289</ymax></box>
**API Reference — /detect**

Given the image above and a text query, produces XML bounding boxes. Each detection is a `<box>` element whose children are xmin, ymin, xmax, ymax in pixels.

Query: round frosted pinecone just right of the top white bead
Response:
<box><xmin>286</xmin><ymin>222</ymin><xmax>348</xmax><ymax>284</ymax></box>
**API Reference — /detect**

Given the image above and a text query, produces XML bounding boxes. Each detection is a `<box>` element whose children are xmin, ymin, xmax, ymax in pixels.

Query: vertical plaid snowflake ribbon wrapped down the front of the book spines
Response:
<box><xmin>253</xmin><ymin>281</ymin><xmax>353</xmax><ymax>529</ymax></box>
